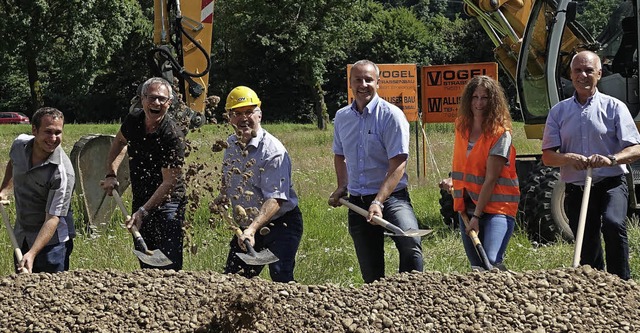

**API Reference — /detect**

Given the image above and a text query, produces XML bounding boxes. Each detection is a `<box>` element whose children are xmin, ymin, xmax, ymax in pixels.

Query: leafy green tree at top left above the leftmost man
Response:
<box><xmin>0</xmin><ymin>0</ymin><xmax>139</xmax><ymax>118</ymax></box>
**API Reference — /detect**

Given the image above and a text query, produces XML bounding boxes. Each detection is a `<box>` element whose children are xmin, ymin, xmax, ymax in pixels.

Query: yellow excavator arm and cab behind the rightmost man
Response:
<box><xmin>463</xmin><ymin>0</ymin><xmax>640</xmax><ymax>139</ymax></box>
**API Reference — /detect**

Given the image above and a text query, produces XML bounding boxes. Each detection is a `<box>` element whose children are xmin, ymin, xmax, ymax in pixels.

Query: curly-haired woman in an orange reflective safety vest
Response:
<box><xmin>440</xmin><ymin>75</ymin><xmax>520</xmax><ymax>269</ymax></box>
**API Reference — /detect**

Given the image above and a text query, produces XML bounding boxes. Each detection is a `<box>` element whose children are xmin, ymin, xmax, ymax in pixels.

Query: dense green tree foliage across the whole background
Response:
<box><xmin>0</xmin><ymin>0</ymin><xmax>620</xmax><ymax>123</ymax></box>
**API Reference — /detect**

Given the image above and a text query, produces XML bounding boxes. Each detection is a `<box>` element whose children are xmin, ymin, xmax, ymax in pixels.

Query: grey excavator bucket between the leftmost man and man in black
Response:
<box><xmin>70</xmin><ymin>134</ymin><xmax>131</xmax><ymax>229</ymax></box>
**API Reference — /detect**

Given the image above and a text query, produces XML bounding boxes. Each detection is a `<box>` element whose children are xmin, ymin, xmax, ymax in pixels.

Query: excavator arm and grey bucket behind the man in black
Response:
<box><xmin>70</xmin><ymin>0</ymin><xmax>219</xmax><ymax>229</ymax></box>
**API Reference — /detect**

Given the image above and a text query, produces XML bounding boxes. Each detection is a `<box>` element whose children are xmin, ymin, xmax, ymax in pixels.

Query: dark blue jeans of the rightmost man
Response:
<box><xmin>564</xmin><ymin>176</ymin><xmax>631</xmax><ymax>280</ymax></box>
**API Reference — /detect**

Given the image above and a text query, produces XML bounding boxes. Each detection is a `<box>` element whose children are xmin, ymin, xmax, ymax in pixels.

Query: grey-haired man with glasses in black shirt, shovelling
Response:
<box><xmin>101</xmin><ymin>78</ymin><xmax>186</xmax><ymax>270</ymax></box>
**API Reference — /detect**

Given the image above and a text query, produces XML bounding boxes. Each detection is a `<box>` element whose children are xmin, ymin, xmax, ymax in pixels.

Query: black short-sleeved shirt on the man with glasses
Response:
<box><xmin>120</xmin><ymin>109</ymin><xmax>186</xmax><ymax>205</ymax></box>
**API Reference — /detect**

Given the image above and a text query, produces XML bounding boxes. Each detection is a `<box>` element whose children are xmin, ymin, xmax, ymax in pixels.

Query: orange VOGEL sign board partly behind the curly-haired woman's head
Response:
<box><xmin>421</xmin><ymin>62</ymin><xmax>498</xmax><ymax>123</ymax></box>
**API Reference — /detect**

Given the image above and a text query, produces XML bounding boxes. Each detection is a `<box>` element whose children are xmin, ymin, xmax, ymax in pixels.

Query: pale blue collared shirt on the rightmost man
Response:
<box><xmin>542</xmin><ymin>91</ymin><xmax>640</xmax><ymax>185</ymax></box>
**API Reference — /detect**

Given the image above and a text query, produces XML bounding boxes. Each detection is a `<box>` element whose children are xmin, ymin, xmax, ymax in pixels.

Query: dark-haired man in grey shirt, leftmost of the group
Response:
<box><xmin>0</xmin><ymin>107</ymin><xmax>75</xmax><ymax>273</ymax></box>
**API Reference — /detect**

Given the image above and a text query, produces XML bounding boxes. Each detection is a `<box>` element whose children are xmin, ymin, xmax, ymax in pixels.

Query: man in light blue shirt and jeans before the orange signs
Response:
<box><xmin>329</xmin><ymin>60</ymin><xmax>423</xmax><ymax>283</ymax></box>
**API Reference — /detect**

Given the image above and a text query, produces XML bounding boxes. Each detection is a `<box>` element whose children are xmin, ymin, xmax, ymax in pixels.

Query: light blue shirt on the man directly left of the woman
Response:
<box><xmin>333</xmin><ymin>95</ymin><xmax>409</xmax><ymax>195</ymax></box>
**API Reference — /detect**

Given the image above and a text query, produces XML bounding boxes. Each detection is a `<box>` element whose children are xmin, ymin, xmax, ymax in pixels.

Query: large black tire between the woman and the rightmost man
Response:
<box><xmin>518</xmin><ymin>164</ymin><xmax>573</xmax><ymax>244</ymax></box>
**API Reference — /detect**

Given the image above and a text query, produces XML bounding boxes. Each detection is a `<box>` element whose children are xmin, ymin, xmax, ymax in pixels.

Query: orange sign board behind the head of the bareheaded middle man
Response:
<box><xmin>347</xmin><ymin>64</ymin><xmax>418</xmax><ymax>122</ymax></box>
